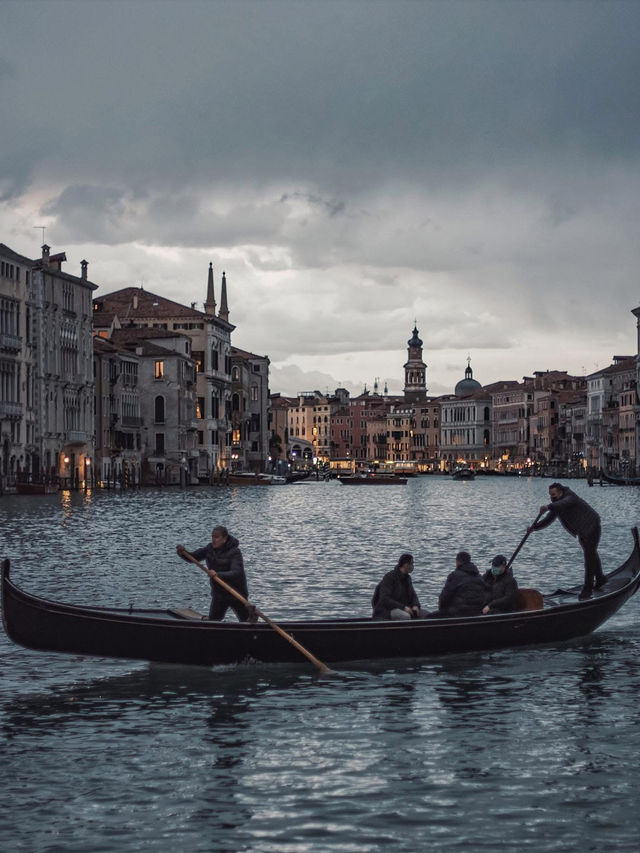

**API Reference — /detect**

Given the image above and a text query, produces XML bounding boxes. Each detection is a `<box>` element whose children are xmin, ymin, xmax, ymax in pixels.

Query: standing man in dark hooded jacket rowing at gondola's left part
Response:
<box><xmin>176</xmin><ymin>526</ymin><xmax>250</xmax><ymax>622</ymax></box>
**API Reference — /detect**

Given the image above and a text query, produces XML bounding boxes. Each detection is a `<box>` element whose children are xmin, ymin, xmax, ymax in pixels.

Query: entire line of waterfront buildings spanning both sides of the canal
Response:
<box><xmin>0</xmin><ymin>244</ymin><xmax>640</xmax><ymax>488</ymax></box>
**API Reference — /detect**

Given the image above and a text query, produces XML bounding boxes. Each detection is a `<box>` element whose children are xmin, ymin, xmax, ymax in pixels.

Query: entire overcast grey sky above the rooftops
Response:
<box><xmin>0</xmin><ymin>0</ymin><xmax>640</xmax><ymax>394</ymax></box>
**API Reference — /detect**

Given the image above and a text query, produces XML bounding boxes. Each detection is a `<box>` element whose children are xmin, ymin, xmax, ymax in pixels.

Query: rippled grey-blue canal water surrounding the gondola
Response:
<box><xmin>0</xmin><ymin>476</ymin><xmax>640</xmax><ymax>853</ymax></box>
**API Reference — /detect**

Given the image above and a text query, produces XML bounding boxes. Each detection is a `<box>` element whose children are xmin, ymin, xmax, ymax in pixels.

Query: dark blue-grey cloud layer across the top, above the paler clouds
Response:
<box><xmin>2</xmin><ymin>0</ymin><xmax>640</xmax><ymax>191</ymax></box>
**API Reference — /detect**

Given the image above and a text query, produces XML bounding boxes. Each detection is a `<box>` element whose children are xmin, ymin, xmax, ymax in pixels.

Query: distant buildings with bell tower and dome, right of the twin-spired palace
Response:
<box><xmin>271</xmin><ymin>326</ymin><xmax>640</xmax><ymax>476</ymax></box>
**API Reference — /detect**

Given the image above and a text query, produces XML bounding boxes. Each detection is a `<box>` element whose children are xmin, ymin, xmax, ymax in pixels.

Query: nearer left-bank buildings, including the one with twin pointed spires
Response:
<box><xmin>0</xmin><ymin>244</ymin><xmax>269</xmax><ymax>488</ymax></box>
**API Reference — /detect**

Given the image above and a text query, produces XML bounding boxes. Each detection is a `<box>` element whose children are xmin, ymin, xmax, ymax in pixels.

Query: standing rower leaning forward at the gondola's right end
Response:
<box><xmin>529</xmin><ymin>483</ymin><xmax>606</xmax><ymax>599</ymax></box>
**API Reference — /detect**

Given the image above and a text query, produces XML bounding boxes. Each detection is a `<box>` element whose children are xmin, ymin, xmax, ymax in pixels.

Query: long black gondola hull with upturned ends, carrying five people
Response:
<box><xmin>2</xmin><ymin>528</ymin><xmax>640</xmax><ymax>666</ymax></box>
